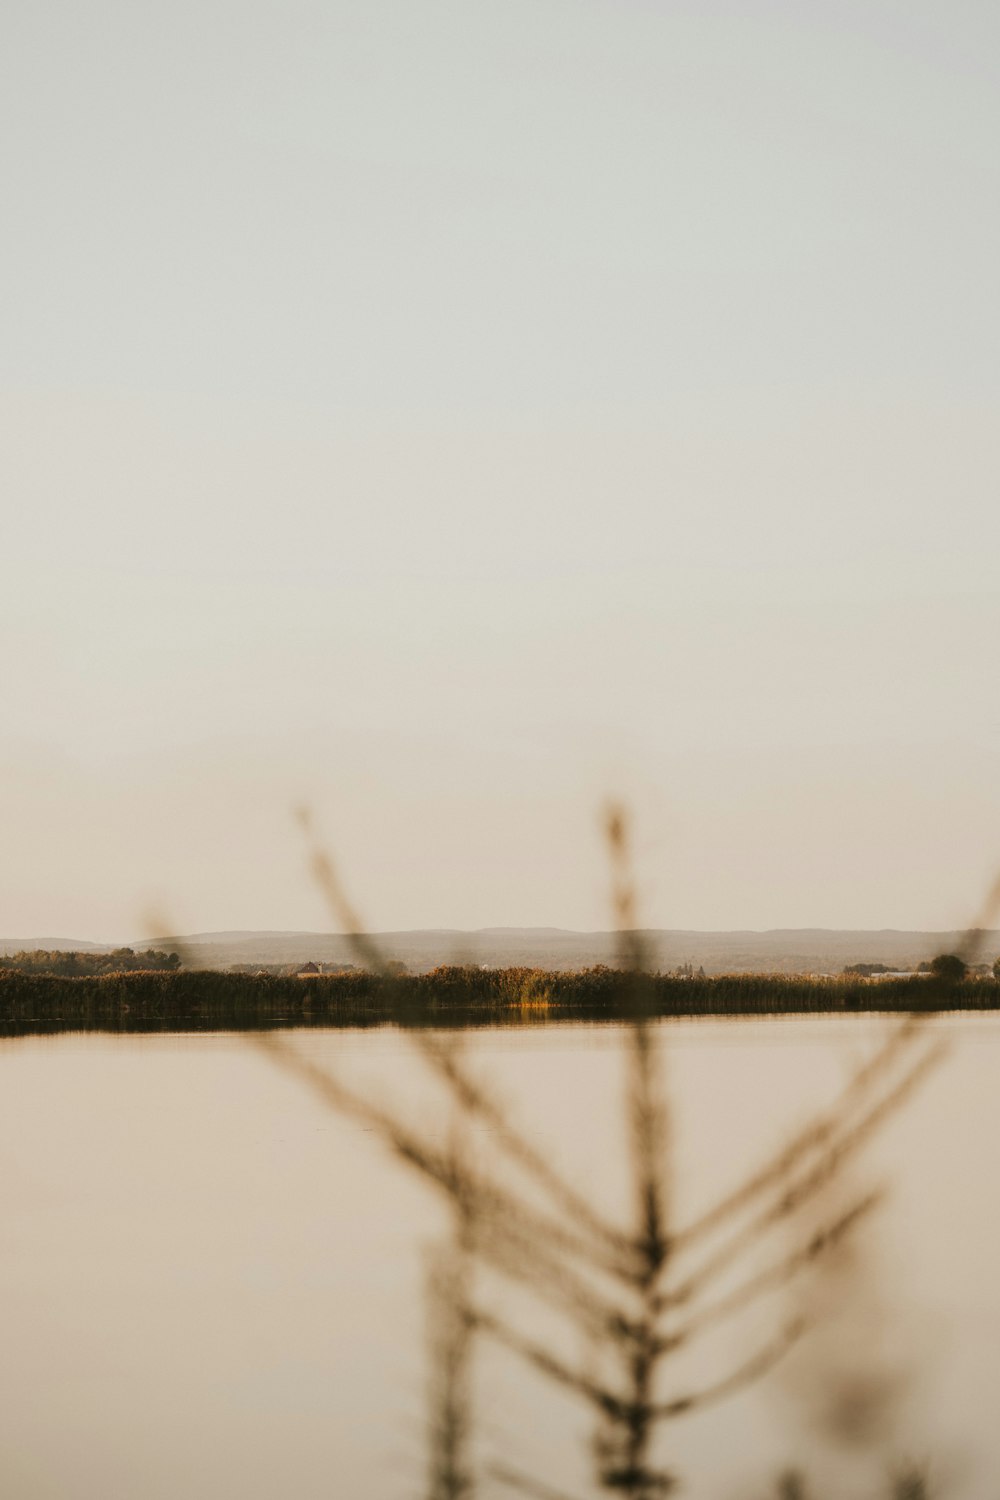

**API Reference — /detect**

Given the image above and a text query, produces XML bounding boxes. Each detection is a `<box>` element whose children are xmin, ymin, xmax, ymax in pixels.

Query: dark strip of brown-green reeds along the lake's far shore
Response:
<box><xmin>0</xmin><ymin>965</ymin><xmax>1000</xmax><ymax>1037</ymax></box>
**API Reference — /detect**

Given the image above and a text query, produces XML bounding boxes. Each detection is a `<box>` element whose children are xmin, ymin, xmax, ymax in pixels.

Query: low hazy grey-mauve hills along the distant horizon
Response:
<box><xmin>0</xmin><ymin>927</ymin><xmax>1000</xmax><ymax>974</ymax></box>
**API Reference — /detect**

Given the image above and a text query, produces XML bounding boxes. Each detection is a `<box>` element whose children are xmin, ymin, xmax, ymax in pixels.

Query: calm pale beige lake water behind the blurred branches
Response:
<box><xmin>0</xmin><ymin>1017</ymin><xmax>1000</xmax><ymax>1500</ymax></box>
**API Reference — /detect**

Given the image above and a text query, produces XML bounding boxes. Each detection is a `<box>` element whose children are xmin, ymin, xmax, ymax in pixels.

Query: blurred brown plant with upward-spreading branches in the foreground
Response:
<box><xmin>251</xmin><ymin>812</ymin><xmax>1000</xmax><ymax>1500</ymax></box>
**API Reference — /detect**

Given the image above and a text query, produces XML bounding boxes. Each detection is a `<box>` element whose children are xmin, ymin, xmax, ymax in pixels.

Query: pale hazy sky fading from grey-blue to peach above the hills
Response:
<box><xmin>0</xmin><ymin>0</ymin><xmax>1000</xmax><ymax>939</ymax></box>
